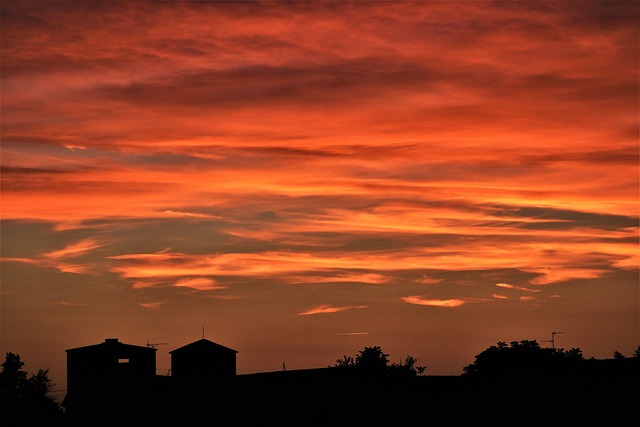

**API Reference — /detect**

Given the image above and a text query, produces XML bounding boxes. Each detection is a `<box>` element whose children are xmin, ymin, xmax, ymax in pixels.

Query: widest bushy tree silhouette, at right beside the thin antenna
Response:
<box><xmin>463</xmin><ymin>340</ymin><xmax>584</xmax><ymax>376</ymax></box>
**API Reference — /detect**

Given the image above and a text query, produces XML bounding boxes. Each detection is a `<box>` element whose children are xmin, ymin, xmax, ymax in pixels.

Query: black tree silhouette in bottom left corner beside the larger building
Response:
<box><xmin>0</xmin><ymin>353</ymin><xmax>62</xmax><ymax>426</ymax></box>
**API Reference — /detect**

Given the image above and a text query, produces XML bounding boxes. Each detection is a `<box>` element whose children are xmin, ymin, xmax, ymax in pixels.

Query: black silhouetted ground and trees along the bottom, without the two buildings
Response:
<box><xmin>0</xmin><ymin>341</ymin><xmax>640</xmax><ymax>427</ymax></box>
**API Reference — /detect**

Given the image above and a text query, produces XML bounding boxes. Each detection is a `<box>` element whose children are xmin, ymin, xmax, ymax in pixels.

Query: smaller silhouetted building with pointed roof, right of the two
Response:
<box><xmin>169</xmin><ymin>338</ymin><xmax>238</xmax><ymax>380</ymax></box>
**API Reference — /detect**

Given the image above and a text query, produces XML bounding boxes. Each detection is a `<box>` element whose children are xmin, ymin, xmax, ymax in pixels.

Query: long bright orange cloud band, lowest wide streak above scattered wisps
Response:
<box><xmin>106</xmin><ymin>237</ymin><xmax>627</xmax><ymax>292</ymax></box>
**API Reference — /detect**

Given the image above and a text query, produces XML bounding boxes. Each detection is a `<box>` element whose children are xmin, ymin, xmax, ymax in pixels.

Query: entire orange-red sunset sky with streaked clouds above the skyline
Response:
<box><xmin>0</xmin><ymin>0</ymin><xmax>640</xmax><ymax>394</ymax></box>
